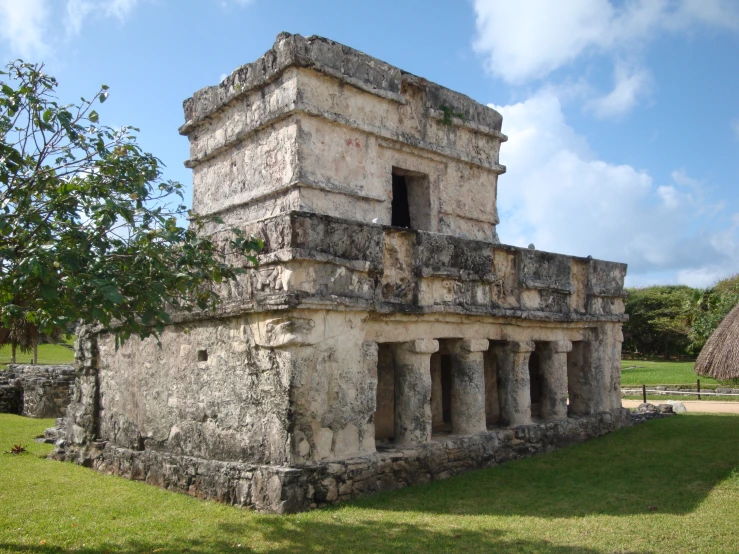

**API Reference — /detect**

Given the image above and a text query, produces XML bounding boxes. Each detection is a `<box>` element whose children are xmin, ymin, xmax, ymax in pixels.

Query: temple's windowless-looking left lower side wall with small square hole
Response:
<box><xmin>96</xmin><ymin>318</ymin><xmax>293</xmax><ymax>464</ymax></box>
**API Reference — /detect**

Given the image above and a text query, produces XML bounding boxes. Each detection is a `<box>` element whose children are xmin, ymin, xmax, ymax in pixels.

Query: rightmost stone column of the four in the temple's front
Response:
<box><xmin>539</xmin><ymin>340</ymin><xmax>572</xmax><ymax>421</ymax></box>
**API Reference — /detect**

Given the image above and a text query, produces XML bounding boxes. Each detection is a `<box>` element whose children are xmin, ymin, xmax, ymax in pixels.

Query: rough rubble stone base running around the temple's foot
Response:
<box><xmin>52</xmin><ymin>409</ymin><xmax>632</xmax><ymax>513</ymax></box>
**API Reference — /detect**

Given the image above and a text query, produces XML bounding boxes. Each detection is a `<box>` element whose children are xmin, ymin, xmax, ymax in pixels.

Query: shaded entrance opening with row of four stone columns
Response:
<box><xmin>374</xmin><ymin>338</ymin><xmax>593</xmax><ymax>447</ymax></box>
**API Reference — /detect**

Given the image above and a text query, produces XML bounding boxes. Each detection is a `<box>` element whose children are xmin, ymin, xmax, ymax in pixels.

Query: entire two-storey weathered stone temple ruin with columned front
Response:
<box><xmin>55</xmin><ymin>33</ymin><xmax>630</xmax><ymax>512</ymax></box>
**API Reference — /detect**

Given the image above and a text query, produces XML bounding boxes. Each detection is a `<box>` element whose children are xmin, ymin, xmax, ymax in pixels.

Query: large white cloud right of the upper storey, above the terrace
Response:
<box><xmin>493</xmin><ymin>90</ymin><xmax>739</xmax><ymax>284</ymax></box>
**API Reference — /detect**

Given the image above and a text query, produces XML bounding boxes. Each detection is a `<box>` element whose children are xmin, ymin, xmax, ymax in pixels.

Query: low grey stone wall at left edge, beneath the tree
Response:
<box><xmin>0</xmin><ymin>364</ymin><xmax>75</xmax><ymax>418</ymax></box>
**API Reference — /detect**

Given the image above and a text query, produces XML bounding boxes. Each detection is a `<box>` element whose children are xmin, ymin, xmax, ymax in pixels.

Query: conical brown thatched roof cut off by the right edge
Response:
<box><xmin>695</xmin><ymin>305</ymin><xmax>739</xmax><ymax>380</ymax></box>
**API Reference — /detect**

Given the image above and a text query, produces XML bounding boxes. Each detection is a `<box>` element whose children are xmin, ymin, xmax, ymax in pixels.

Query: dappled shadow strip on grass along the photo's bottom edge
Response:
<box><xmin>0</xmin><ymin>516</ymin><xmax>616</xmax><ymax>554</ymax></box>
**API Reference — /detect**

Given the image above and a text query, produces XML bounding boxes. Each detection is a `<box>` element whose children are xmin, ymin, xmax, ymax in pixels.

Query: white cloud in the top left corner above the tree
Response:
<box><xmin>0</xmin><ymin>0</ymin><xmax>50</xmax><ymax>61</ymax></box>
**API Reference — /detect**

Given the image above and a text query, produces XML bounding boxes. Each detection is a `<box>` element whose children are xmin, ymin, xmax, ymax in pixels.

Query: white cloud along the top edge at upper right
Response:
<box><xmin>475</xmin><ymin>0</ymin><xmax>739</xmax><ymax>84</ymax></box>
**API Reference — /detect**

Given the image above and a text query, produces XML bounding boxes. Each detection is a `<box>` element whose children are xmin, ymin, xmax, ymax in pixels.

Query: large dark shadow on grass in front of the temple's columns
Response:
<box><xmin>351</xmin><ymin>415</ymin><xmax>739</xmax><ymax>518</ymax></box>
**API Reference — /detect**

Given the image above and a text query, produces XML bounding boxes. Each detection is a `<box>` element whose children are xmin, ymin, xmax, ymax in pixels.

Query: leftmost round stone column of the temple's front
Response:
<box><xmin>393</xmin><ymin>339</ymin><xmax>439</xmax><ymax>444</ymax></box>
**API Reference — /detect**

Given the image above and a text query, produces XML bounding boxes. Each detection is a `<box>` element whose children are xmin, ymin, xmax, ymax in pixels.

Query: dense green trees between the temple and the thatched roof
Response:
<box><xmin>624</xmin><ymin>274</ymin><xmax>739</xmax><ymax>358</ymax></box>
